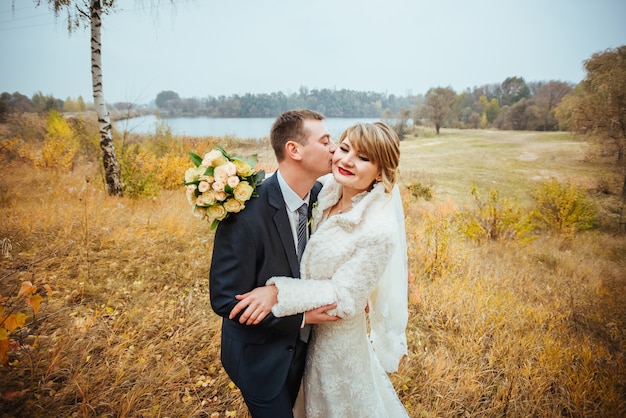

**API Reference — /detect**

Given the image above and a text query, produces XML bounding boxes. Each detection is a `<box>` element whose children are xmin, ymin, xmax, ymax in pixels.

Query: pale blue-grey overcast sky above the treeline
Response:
<box><xmin>0</xmin><ymin>0</ymin><xmax>626</xmax><ymax>104</ymax></box>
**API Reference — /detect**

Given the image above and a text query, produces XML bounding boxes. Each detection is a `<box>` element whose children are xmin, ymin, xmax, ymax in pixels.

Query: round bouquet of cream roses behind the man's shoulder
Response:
<box><xmin>185</xmin><ymin>146</ymin><xmax>265</xmax><ymax>229</ymax></box>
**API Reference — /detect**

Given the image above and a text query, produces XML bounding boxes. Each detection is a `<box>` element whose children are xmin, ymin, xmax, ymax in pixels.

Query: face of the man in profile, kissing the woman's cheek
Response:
<box><xmin>300</xmin><ymin>119</ymin><xmax>337</xmax><ymax>178</ymax></box>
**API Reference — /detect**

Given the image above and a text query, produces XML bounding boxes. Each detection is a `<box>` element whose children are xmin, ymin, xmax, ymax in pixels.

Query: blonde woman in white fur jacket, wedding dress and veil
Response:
<box><xmin>230</xmin><ymin>122</ymin><xmax>408</xmax><ymax>418</ymax></box>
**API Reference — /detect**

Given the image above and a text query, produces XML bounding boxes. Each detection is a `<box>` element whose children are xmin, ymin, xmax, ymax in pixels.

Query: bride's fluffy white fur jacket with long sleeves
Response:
<box><xmin>267</xmin><ymin>176</ymin><xmax>396</xmax><ymax>318</ymax></box>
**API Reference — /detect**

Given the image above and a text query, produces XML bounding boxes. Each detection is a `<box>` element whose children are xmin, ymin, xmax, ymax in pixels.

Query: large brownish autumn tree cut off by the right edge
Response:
<box><xmin>557</xmin><ymin>45</ymin><xmax>626</xmax><ymax>202</ymax></box>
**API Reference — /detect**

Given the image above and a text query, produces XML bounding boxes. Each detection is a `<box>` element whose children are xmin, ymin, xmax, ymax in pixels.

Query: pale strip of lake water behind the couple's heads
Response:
<box><xmin>115</xmin><ymin>115</ymin><xmax>380</xmax><ymax>140</ymax></box>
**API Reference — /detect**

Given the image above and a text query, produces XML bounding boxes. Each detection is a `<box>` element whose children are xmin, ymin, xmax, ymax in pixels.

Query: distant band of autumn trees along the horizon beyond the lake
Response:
<box><xmin>0</xmin><ymin>77</ymin><xmax>573</xmax><ymax>135</ymax></box>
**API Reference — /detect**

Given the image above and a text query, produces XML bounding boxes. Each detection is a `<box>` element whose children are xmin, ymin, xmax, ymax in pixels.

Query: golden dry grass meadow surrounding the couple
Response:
<box><xmin>0</xmin><ymin>119</ymin><xmax>626</xmax><ymax>418</ymax></box>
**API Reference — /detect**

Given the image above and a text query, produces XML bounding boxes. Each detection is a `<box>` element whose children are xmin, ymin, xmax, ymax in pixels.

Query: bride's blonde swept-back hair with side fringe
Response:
<box><xmin>339</xmin><ymin>122</ymin><xmax>400</xmax><ymax>193</ymax></box>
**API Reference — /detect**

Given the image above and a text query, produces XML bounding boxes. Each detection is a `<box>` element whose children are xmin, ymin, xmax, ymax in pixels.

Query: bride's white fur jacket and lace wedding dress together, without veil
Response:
<box><xmin>268</xmin><ymin>181</ymin><xmax>408</xmax><ymax>418</ymax></box>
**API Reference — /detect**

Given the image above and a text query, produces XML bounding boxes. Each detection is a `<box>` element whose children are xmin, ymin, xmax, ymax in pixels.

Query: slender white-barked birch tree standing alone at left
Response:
<box><xmin>36</xmin><ymin>0</ymin><xmax>122</xmax><ymax>196</ymax></box>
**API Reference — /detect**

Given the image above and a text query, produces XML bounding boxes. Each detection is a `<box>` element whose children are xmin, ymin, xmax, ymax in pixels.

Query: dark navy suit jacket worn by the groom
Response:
<box><xmin>209</xmin><ymin>175</ymin><xmax>321</xmax><ymax>400</ymax></box>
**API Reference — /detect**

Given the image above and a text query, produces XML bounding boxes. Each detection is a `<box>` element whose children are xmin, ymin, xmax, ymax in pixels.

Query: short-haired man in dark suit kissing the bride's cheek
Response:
<box><xmin>209</xmin><ymin>110</ymin><xmax>336</xmax><ymax>418</ymax></box>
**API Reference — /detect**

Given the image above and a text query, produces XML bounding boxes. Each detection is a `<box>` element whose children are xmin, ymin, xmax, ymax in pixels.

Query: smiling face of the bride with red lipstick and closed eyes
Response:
<box><xmin>333</xmin><ymin>137</ymin><xmax>381</xmax><ymax>193</ymax></box>
